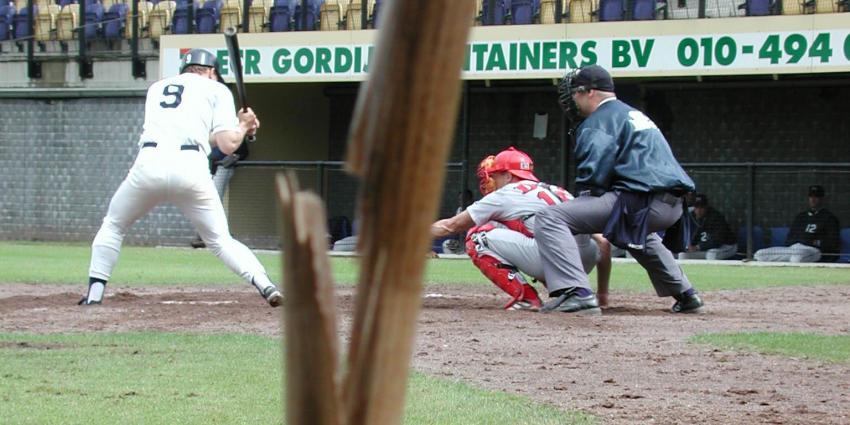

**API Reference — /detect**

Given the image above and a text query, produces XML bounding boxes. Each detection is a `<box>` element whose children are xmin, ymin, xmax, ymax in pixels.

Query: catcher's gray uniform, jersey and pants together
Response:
<box><xmin>466</xmin><ymin>180</ymin><xmax>600</xmax><ymax>281</ymax></box>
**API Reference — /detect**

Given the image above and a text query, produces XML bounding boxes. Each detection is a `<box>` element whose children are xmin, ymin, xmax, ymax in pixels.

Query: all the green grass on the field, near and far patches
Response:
<box><xmin>0</xmin><ymin>242</ymin><xmax>850</xmax><ymax>425</ymax></box>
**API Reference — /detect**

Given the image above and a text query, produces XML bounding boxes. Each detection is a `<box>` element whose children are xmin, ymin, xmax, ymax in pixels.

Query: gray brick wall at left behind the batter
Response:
<box><xmin>0</xmin><ymin>98</ymin><xmax>193</xmax><ymax>244</ymax></box>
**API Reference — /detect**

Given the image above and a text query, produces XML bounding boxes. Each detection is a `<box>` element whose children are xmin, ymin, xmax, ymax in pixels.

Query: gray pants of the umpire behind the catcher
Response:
<box><xmin>534</xmin><ymin>192</ymin><xmax>691</xmax><ymax>297</ymax></box>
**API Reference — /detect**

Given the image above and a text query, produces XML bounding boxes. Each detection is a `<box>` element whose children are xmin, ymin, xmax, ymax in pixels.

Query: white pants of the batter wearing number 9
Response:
<box><xmin>89</xmin><ymin>144</ymin><xmax>271</xmax><ymax>289</ymax></box>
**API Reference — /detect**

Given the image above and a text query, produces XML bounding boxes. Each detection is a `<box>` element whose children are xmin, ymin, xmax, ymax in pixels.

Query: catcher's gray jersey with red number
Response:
<box><xmin>466</xmin><ymin>180</ymin><xmax>573</xmax><ymax>236</ymax></box>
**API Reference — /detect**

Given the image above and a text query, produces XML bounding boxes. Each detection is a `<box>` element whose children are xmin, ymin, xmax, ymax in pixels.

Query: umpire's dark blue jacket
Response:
<box><xmin>576</xmin><ymin>98</ymin><xmax>694</xmax><ymax>192</ymax></box>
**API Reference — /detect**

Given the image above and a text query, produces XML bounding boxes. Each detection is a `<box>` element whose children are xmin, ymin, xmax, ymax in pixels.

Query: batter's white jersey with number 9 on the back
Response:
<box><xmin>139</xmin><ymin>72</ymin><xmax>239</xmax><ymax>155</ymax></box>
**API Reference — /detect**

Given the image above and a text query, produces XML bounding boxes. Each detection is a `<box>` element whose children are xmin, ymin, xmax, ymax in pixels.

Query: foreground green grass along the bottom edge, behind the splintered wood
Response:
<box><xmin>0</xmin><ymin>333</ymin><xmax>593</xmax><ymax>425</ymax></box>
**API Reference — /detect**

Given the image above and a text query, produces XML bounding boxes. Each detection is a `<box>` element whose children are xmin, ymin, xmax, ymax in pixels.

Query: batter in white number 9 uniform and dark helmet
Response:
<box><xmin>80</xmin><ymin>49</ymin><xmax>283</xmax><ymax>307</ymax></box>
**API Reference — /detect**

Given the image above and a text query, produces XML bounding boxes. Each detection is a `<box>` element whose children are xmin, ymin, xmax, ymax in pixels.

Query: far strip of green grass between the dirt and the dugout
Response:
<box><xmin>0</xmin><ymin>242</ymin><xmax>850</xmax><ymax>292</ymax></box>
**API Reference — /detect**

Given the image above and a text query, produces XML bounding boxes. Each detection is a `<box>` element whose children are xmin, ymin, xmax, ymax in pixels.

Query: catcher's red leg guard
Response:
<box><xmin>466</xmin><ymin>227</ymin><xmax>542</xmax><ymax>310</ymax></box>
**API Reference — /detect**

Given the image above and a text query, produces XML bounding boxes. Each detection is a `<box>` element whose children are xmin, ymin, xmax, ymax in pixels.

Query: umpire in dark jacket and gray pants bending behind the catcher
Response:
<box><xmin>535</xmin><ymin>65</ymin><xmax>703</xmax><ymax>314</ymax></box>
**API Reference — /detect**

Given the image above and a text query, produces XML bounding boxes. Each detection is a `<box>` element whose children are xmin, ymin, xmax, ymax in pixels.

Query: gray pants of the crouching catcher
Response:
<box><xmin>472</xmin><ymin>228</ymin><xmax>600</xmax><ymax>282</ymax></box>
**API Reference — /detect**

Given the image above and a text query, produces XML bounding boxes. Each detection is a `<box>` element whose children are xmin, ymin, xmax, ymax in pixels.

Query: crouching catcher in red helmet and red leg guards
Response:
<box><xmin>431</xmin><ymin>148</ymin><xmax>611</xmax><ymax>311</ymax></box>
